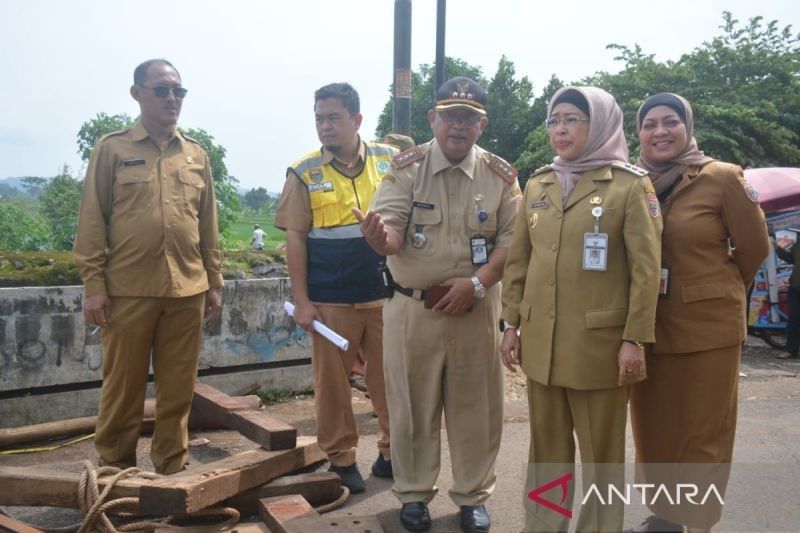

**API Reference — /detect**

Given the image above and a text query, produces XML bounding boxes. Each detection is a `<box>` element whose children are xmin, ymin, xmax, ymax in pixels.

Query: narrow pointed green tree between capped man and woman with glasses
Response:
<box><xmin>480</xmin><ymin>56</ymin><xmax>536</xmax><ymax>163</ymax></box>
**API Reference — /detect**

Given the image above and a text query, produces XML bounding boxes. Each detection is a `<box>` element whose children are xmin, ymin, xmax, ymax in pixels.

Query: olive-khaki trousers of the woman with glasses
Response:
<box><xmin>523</xmin><ymin>378</ymin><xmax>629</xmax><ymax>531</ymax></box>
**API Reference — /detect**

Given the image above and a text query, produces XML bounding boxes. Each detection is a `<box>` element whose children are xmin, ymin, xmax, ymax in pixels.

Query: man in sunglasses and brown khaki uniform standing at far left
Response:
<box><xmin>74</xmin><ymin>59</ymin><xmax>222</xmax><ymax>474</ymax></box>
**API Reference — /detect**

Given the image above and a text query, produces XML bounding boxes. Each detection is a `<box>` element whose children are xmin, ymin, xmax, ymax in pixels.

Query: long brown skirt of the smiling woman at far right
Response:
<box><xmin>631</xmin><ymin>343</ymin><xmax>741</xmax><ymax>529</ymax></box>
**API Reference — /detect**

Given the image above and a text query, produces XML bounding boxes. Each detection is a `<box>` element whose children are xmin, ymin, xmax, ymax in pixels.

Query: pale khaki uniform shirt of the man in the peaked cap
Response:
<box><xmin>370</xmin><ymin>140</ymin><xmax>521</xmax><ymax>289</ymax></box>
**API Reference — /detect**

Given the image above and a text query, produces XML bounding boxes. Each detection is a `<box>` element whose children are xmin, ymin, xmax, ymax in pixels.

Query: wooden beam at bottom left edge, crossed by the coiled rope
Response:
<box><xmin>0</xmin><ymin>466</ymin><xmax>145</xmax><ymax>509</ymax></box>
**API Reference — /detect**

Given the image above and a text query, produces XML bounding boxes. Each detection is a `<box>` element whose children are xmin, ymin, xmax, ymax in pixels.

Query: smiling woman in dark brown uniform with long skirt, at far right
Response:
<box><xmin>631</xmin><ymin>93</ymin><xmax>770</xmax><ymax>531</ymax></box>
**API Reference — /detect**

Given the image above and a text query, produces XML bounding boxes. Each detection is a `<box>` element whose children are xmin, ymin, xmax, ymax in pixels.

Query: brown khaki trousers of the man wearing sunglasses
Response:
<box><xmin>94</xmin><ymin>293</ymin><xmax>205</xmax><ymax>474</ymax></box>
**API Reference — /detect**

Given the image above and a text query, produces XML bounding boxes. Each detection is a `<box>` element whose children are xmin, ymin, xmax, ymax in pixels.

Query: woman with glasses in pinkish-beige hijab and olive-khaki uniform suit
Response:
<box><xmin>500</xmin><ymin>87</ymin><xmax>661</xmax><ymax>531</ymax></box>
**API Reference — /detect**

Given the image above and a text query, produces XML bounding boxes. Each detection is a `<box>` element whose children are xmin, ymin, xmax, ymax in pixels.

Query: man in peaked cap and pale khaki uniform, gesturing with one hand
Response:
<box><xmin>359</xmin><ymin>78</ymin><xmax>520</xmax><ymax>531</ymax></box>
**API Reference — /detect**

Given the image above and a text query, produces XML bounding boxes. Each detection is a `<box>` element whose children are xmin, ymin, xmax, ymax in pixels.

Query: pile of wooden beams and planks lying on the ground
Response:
<box><xmin>0</xmin><ymin>383</ymin><xmax>382</xmax><ymax>533</ymax></box>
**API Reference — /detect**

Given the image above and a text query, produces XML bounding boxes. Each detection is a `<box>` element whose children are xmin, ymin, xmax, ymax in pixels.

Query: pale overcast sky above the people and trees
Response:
<box><xmin>0</xmin><ymin>0</ymin><xmax>800</xmax><ymax>192</ymax></box>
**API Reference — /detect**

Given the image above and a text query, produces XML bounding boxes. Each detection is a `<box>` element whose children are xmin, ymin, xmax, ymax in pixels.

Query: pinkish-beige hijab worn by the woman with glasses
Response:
<box><xmin>547</xmin><ymin>87</ymin><xmax>628</xmax><ymax>201</ymax></box>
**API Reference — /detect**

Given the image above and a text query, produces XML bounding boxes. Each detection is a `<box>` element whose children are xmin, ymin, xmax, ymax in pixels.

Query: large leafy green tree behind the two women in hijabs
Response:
<box><xmin>585</xmin><ymin>11</ymin><xmax>800</xmax><ymax>166</ymax></box>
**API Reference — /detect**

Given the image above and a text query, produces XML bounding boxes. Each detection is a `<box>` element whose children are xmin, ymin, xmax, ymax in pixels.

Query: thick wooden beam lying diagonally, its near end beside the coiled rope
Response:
<box><xmin>139</xmin><ymin>437</ymin><xmax>325</xmax><ymax>515</ymax></box>
